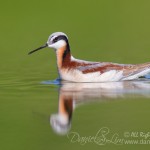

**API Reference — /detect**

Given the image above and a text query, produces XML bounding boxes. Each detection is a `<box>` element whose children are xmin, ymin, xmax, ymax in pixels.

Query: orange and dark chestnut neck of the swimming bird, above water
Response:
<box><xmin>56</xmin><ymin>44</ymin><xmax>71</xmax><ymax>69</ymax></box>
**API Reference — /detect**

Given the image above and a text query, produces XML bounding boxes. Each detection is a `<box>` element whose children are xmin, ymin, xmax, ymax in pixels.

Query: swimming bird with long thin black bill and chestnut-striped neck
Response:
<box><xmin>28</xmin><ymin>32</ymin><xmax>150</xmax><ymax>82</ymax></box>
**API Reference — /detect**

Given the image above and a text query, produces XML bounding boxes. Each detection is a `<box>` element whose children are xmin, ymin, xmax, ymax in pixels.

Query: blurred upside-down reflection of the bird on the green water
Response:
<box><xmin>50</xmin><ymin>80</ymin><xmax>150</xmax><ymax>135</ymax></box>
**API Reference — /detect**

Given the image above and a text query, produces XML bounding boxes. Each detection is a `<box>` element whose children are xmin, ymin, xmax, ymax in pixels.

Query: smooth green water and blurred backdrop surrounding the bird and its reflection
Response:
<box><xmin>0</xmin><ymin>0</ymin><xmax>150</xmax><ymax>150</ymax></box>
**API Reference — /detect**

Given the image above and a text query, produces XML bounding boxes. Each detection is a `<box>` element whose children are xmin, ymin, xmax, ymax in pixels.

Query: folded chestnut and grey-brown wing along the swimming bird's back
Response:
<box><xmin>77</xmin><ymin>62</ymin><xmax>150</xmax><ymax>79</ymax></box>
